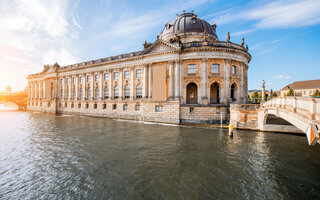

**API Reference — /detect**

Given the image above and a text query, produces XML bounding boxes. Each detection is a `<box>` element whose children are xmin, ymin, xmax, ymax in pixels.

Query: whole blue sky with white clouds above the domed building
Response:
<box><xmin>0</xmin><ymin>0</ymin><xmax>320</xmax><ymax>91</ymax></box>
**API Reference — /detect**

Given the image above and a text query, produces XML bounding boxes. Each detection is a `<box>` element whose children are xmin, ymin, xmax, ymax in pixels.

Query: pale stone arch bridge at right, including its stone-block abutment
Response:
<box><xmin>230</xmin><ymin>97</ymin><xmax>320</xmax><ymax>142</ymax></box>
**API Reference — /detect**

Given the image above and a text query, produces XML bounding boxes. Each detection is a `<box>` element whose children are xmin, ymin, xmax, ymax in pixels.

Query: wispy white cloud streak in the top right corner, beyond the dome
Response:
<box><xmin>210</xmin><ymin>0</ymin><xmax>320</xmax><ymax>29</ymax></box>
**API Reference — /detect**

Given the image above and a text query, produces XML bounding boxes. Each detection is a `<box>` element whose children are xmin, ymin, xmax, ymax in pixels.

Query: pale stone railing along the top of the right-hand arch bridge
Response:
<box><xmin>261</xmin><ymin>97</ymin><xmax>320</xmax><ymax>120</ymax></box>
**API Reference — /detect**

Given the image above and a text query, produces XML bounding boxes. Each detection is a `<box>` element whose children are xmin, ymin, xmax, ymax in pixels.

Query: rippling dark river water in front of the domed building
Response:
<box><xmin>0</xmin><ymin>111</ymin><xmax>320</xmax><ymax>199</ymax></box>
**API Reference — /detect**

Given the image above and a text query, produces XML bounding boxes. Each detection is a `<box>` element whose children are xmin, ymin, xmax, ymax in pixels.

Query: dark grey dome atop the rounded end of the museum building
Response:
<box><xmin>159</xmin><ymin>13</ymin><xmax>218</xmax><ymax>39</ymax></box>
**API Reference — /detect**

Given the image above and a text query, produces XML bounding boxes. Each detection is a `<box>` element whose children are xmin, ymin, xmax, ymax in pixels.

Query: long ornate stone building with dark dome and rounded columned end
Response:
<box><xmin>27</xmin><ymin>13</ymin><xmax>251</xmax><ymax>124</ymax></box>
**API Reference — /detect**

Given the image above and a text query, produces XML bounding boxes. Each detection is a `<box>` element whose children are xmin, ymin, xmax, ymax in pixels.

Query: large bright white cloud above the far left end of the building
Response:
<box><xmin>0</xmin><ymin>0</ymin><xmax>81</xmax><ymax>90</ymax></box>
